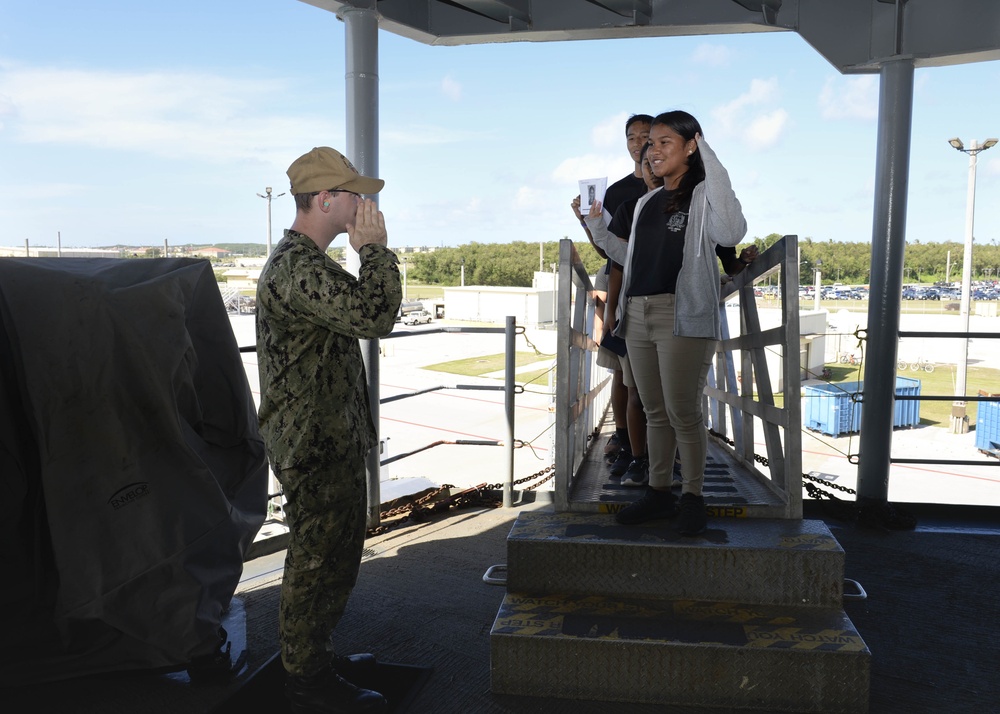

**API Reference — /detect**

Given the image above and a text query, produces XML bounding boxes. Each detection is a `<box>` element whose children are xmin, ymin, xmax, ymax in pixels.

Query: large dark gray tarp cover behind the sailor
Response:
<box><xmin>0</xmin><ymin>258</ymin><xmax>267</xmax><ymax>684</ymax></box>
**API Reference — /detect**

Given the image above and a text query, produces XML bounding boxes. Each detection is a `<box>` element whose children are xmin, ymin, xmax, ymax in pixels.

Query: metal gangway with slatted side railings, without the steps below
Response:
<box><xmin>554</xmin><ymin>235</ymin><xmax>802</xmax><ymax>519</ymax></box>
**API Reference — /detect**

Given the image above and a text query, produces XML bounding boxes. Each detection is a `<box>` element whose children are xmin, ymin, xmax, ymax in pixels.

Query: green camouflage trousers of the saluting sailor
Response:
<box><xmin>277</xmin><ymin>461</ymin><xmax>367</xmax><ymax>676</ymax></box>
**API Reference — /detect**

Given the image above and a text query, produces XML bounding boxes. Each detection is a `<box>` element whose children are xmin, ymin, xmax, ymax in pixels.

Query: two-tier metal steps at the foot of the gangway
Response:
<box><xmin>490</xmin><ymin>512</ymin><xmax>870</xmax><ymax>714</ymax></box>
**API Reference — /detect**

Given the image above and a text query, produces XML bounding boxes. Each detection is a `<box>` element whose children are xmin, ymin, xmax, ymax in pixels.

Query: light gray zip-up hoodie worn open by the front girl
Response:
<box><xmin>586</xmin><ymin>137</ymin><xmax>747</xmax><ymax>340</ymax></box>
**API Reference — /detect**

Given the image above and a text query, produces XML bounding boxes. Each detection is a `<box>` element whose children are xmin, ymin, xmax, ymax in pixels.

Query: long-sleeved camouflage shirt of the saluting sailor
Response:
<box><xmin>256</xmin><ymin>230</ymin><xmax>402</xmax><ymax>471</ymax></box>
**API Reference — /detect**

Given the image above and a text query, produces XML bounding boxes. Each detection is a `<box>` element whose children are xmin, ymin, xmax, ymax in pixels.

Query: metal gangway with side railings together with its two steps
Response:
<box><xmin>490</xmin><ymin>236</ymin><xmax>870</xmax><ymax>713</ymax></box>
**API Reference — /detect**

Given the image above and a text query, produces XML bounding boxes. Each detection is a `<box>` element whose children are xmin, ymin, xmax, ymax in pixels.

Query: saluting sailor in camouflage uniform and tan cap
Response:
<box><xmin>257</xmin><ymin>147</ymin><xmax>402</xmax><ymax>713</ymax></box>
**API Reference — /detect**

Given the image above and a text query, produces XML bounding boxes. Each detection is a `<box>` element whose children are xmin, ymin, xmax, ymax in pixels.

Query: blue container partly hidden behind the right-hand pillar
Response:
<box><xmin>802</xmin><ymin>377</ymin><xmax>920</xmax><ymax>436</ymax></box>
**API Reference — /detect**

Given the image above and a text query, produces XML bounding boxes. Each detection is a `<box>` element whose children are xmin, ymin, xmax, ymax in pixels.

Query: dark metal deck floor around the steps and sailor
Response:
<box><xmin>0</xmin><ymin>501</ymin><xmax>1000</xmax><ymax>714</ymax></box>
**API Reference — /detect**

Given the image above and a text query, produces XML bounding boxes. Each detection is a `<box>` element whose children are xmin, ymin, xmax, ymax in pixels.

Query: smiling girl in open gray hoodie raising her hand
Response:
<box><xmin>587</xmin><ymin>111</ymin><xmax>747</xmax><ymax>535</ymax></box>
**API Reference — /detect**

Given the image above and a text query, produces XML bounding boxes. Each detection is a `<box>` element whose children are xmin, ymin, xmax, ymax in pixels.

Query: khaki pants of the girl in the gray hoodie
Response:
<box><xmin>625</xmin><ymin>294</ymin><xmax>716</xmax><ymax>495</ymax></box>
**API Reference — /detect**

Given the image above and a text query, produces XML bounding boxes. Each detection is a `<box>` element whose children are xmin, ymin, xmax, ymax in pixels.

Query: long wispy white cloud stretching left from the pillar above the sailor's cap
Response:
<box><xmin>0</xmin><ymin>66</ymin><xmax>342</xmax><ymax>164</ymax></box>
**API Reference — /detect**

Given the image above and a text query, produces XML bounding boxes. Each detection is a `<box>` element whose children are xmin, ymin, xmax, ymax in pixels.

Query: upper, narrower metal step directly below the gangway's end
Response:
<box><xmin>507</xmin><ymin>511</ymin><xmax>844</xmax><ymax>609</ymax></box>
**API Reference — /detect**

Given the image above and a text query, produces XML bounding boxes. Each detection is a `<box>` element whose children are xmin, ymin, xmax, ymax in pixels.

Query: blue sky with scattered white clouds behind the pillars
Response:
<box><xmin>0</xmin><ymin>0</ymin><xmax>1000</xmax><ymax>252</ymax></box>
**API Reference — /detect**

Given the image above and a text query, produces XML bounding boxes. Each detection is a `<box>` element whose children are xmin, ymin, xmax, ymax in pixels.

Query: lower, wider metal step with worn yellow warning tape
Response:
<box><xmin>490</xmin><ymin>590</ymin><xmax>871</xmax><ymax>714</ymax></box>
